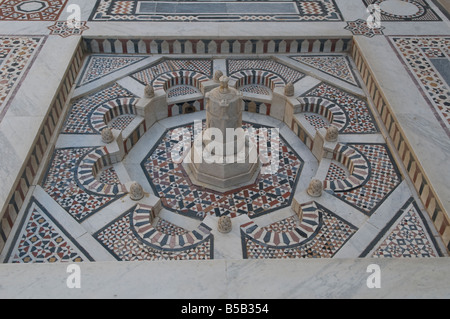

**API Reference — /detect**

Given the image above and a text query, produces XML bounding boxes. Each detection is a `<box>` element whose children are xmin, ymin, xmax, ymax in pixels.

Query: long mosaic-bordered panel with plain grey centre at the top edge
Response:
<box><xmin>89</xmin><ymin>0</ymin><xmax>342</xmax><ymax>22</ymax></box>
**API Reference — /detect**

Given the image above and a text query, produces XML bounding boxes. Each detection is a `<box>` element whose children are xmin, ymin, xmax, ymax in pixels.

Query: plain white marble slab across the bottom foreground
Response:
<box><xmin>0</xmin><ymin>258</ymin><xmax>450</xmax><ymax>300</ymax></box>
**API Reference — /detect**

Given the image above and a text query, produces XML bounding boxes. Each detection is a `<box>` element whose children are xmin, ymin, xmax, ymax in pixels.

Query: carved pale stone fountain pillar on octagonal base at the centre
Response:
<box><xmin>184</xmin><ymin>76</ymin><xmax>260</xmax><ymax>192</ymax></box>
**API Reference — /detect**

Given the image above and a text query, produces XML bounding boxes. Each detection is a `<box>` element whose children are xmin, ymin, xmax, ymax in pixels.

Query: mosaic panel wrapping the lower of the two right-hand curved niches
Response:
<box><xmin>327</xmin><ymin>144</ymin><xmax>402</xmax><ymax>216</ymax></box>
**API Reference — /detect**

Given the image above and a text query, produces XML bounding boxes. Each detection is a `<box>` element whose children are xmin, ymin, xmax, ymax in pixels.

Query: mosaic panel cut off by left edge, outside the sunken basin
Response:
<box><xmin>0</xmin><ymin>36</ymin><xmax>45</xmax><ymax>121</ymax></box>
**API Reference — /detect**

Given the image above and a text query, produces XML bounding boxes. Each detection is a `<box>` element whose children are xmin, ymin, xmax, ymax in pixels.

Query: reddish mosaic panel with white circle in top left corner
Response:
<box><xmin>0</xmin><ymin>0</ymin><xmax>67</xmax><ymax>21</ymax></box>
